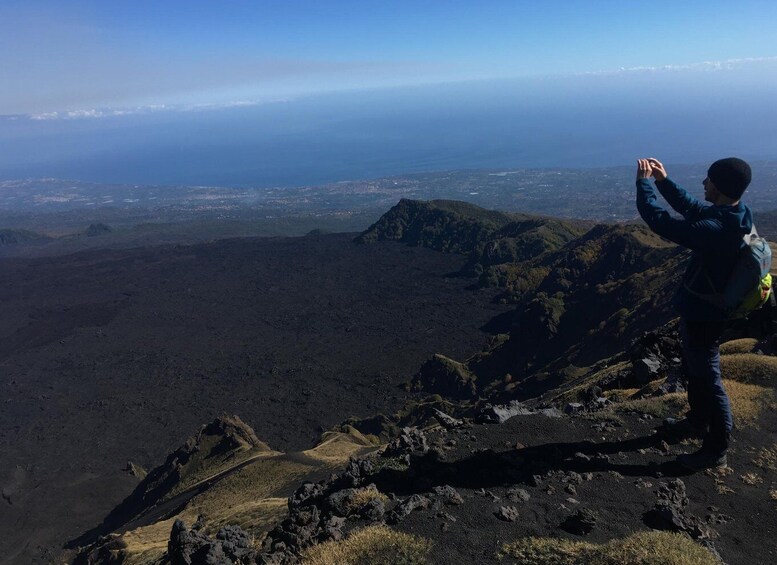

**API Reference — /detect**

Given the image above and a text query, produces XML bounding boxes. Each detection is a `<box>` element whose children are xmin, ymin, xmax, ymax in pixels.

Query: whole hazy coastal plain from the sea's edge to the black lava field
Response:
<box><xmin>0</xmin><ymin>161</ymin><xmax>777</xmax><ymax>256</ymax></box>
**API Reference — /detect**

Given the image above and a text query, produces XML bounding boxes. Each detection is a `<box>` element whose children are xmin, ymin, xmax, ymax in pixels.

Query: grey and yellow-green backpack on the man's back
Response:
<box><xmin>685</xmin><ymin>226</ymin><xmax>772</xmax><ymax>320</ymax></box>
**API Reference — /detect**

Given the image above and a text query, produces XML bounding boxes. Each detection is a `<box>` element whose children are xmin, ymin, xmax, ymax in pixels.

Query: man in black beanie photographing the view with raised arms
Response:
<box><xmin>637</xmin><ymin>157</ymin><xmax>753</xmax><ymax>471</ymax></box>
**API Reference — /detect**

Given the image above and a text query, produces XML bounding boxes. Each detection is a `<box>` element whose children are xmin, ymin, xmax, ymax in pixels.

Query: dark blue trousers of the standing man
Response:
<box><xmin>680</xmin><ymin>319</ymin><xmax>734</xmax><ymax>455</ymax></box>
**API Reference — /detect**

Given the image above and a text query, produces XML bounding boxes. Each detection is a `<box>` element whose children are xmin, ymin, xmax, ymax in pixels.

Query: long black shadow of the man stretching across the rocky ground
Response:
<box><xmin>370</xmin><ymin>435</ymin><xmax>691</xmax><ymax>496</ymax></box>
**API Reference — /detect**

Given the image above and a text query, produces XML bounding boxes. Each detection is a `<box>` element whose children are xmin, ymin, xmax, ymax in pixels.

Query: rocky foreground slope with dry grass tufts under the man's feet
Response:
<box><xmin>77</xmin><ymin>328</ymin><xmax>777</xmax><ymax>565</ymax></box>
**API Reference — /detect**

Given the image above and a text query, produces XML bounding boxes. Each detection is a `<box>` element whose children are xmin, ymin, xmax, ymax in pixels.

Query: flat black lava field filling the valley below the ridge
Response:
<box><xmin>0</xmin><ymin>231</ymin><xmax>505</xmax><ymax>563</ymax></box>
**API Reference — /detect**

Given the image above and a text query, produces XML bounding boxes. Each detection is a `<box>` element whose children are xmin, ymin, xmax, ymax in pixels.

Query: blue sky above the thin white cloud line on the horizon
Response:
<box><xmin>0</xmin><ymin>0</ymin><xmax>777</xmax><ymax>115</ymax></box>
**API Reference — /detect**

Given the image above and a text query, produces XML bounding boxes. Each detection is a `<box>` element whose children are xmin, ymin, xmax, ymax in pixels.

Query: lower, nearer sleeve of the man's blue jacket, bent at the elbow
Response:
<box><xmin>637</xmin><ymin>179</ymin><xmax>720</xmax><ymax>250</ymax></box>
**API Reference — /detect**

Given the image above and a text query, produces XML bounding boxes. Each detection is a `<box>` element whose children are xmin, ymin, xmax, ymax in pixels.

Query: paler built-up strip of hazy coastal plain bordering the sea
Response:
<box><xmin>0</xmin><ymin>162</ymin><xmax>777</xmax><ymax>228</ymax></box>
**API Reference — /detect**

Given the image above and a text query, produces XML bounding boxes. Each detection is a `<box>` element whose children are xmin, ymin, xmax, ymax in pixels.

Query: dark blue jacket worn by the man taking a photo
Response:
<box><xmin>637</xmin><ymin>179</ymin><xmax>753</xmax><ymax>321</ymax></box>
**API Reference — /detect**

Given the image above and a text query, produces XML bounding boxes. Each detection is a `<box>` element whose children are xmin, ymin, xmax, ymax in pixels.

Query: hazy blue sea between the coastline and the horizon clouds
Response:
<box><xmin>0</xmin><ymin>74</ymin><xmax>777</xmax><ymax>187</ymax></box>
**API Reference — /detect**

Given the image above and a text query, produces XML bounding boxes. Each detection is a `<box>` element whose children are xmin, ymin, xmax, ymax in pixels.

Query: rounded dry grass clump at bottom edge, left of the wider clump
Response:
<box><xmin>302</xmin><ymin>526</ymin><xmax>432</xmax><ymax>565</ymax></box>
